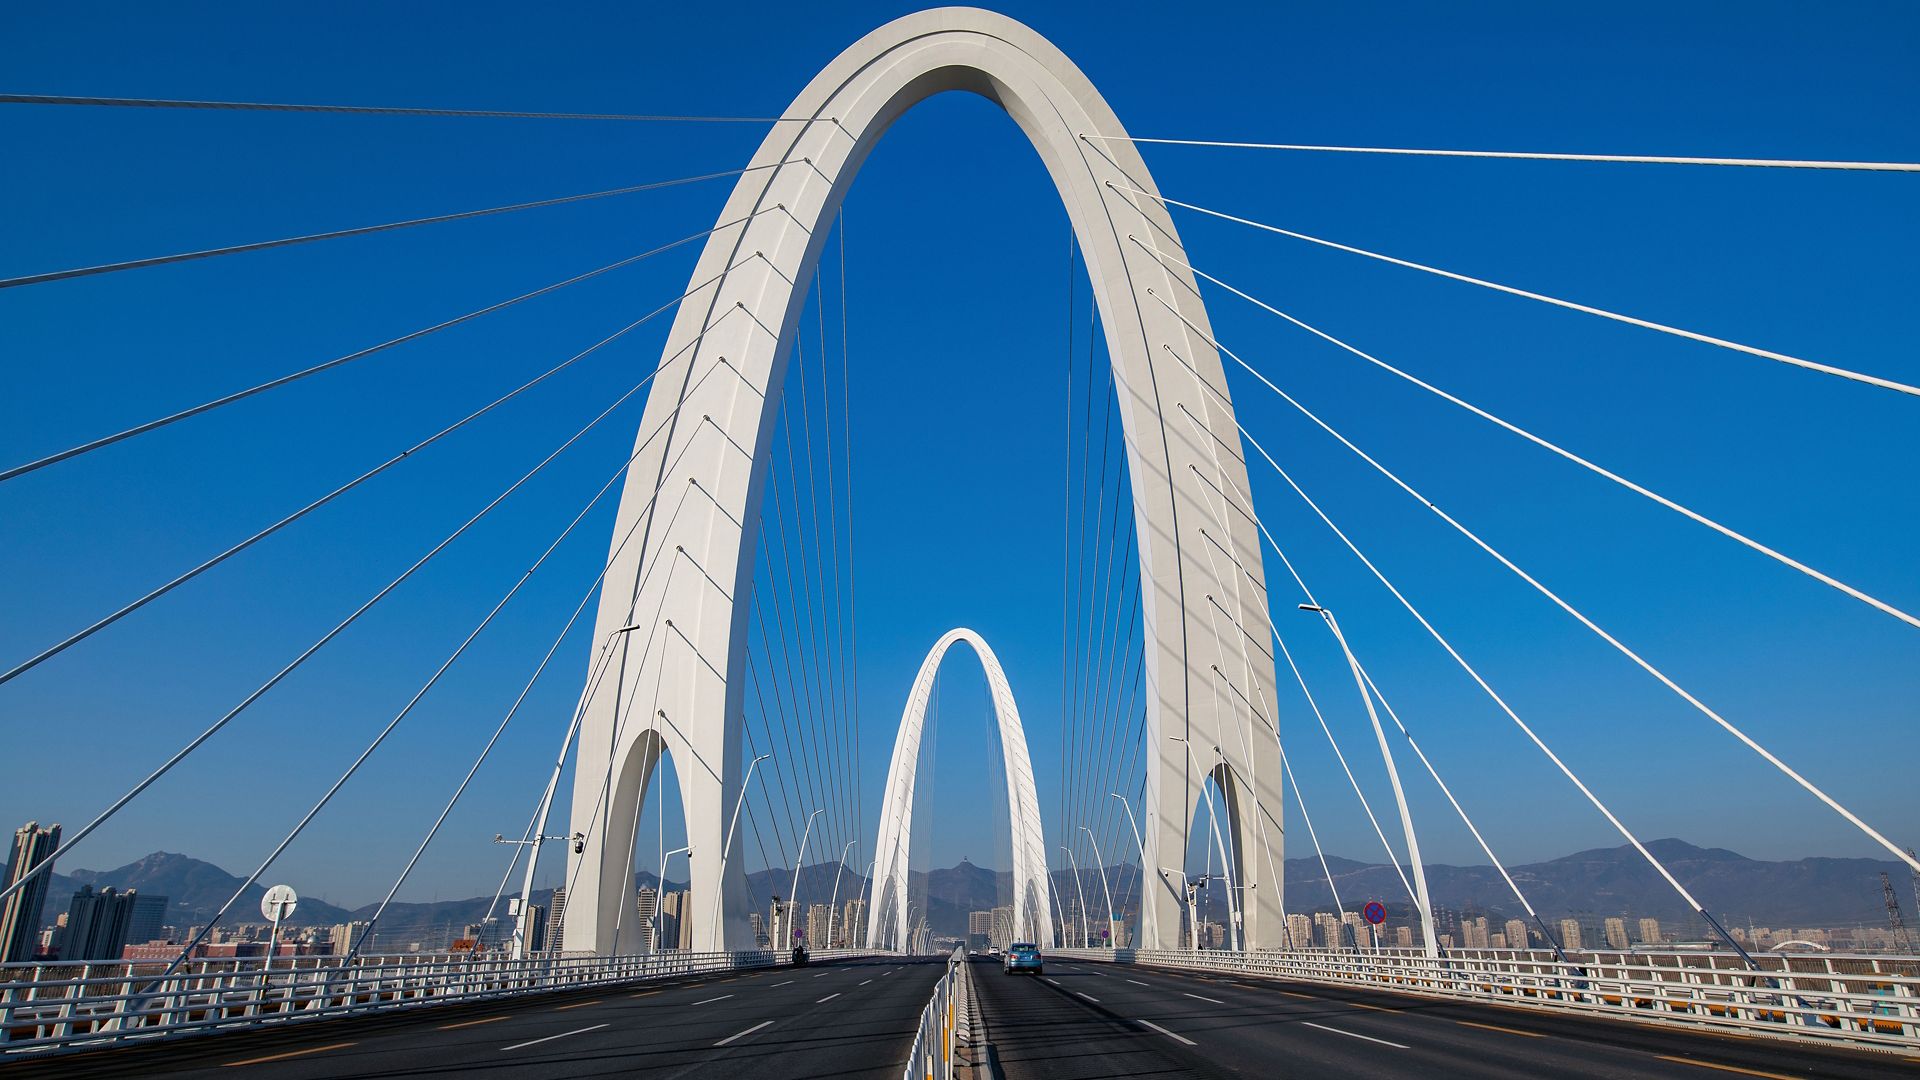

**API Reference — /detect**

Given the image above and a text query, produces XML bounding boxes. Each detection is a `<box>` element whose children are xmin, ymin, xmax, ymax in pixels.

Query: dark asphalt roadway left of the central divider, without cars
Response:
<box><xmin>0</xmin><ymin>957</ymin><xmax>947</xmax><ymax>1080</ymax></box>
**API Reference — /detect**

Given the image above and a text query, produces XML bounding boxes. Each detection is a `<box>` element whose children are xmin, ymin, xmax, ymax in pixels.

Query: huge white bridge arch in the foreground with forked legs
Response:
<box><xmin>564</xmin><ymin>8</ymin><xmax>1283</xmax><ymax>951</ymax></box>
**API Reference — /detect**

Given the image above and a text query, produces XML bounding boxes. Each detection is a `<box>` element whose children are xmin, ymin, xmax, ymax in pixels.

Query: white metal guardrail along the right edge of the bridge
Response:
<box><xmin>1056</xmin><ymin>949</ymin><xmax>1920</xmax><ymax>1053</ymax></box>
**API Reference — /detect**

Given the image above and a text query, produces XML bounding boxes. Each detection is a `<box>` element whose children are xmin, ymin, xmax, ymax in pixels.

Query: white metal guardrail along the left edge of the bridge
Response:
<box><xmin>0</xmin><ymin>949</ymin><xmax>866</xmax><ymax>1063</ymax></box>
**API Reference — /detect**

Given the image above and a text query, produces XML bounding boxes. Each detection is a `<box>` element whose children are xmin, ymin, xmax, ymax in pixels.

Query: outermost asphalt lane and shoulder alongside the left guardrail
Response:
<box><xmin>6</xmin><ymin>961</ymin><xmax>906</xmax><ymax>1080</ymax></box>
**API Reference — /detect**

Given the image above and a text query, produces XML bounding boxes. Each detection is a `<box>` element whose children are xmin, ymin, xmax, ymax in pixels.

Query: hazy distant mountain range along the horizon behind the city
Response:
<box><xmin>44</xmin><ymin>840</ymin><xmax>1920</xmax><ymax>934</ymax></box>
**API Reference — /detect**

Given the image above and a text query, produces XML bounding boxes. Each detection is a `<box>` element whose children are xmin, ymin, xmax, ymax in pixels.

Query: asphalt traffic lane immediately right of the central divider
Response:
<box><xmin>973</xmin><ymin>963</ymin><xmax>1233</xmax><ymax>1080</ymax></box>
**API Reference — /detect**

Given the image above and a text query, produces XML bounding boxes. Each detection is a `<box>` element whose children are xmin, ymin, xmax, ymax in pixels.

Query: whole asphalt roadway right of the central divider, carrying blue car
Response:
<box><xmin>973</xmin><ymin>961</ymin><xmax>1920</xmax><ymax>1080</ymax></box>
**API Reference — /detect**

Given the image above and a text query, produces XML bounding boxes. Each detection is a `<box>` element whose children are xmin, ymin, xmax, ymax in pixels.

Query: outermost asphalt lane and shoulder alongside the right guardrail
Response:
<box><xmin>1081</xmin><ymin>963</ymin><xmax>1912</xmax><ymax>1080</ymax></box>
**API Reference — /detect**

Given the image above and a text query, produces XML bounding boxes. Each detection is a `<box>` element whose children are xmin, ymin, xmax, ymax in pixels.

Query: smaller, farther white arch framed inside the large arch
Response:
<box><xmin>866</xmin><ymin>626</ymin><xmax>1054</xmax><ymax>949</ymax></box>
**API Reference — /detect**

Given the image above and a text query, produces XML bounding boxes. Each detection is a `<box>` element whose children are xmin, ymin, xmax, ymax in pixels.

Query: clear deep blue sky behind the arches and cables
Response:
<box><xmin>0</xmin><ymin>2</ymin><xmax>1920</xmax><ymax>903</ymax></box>
